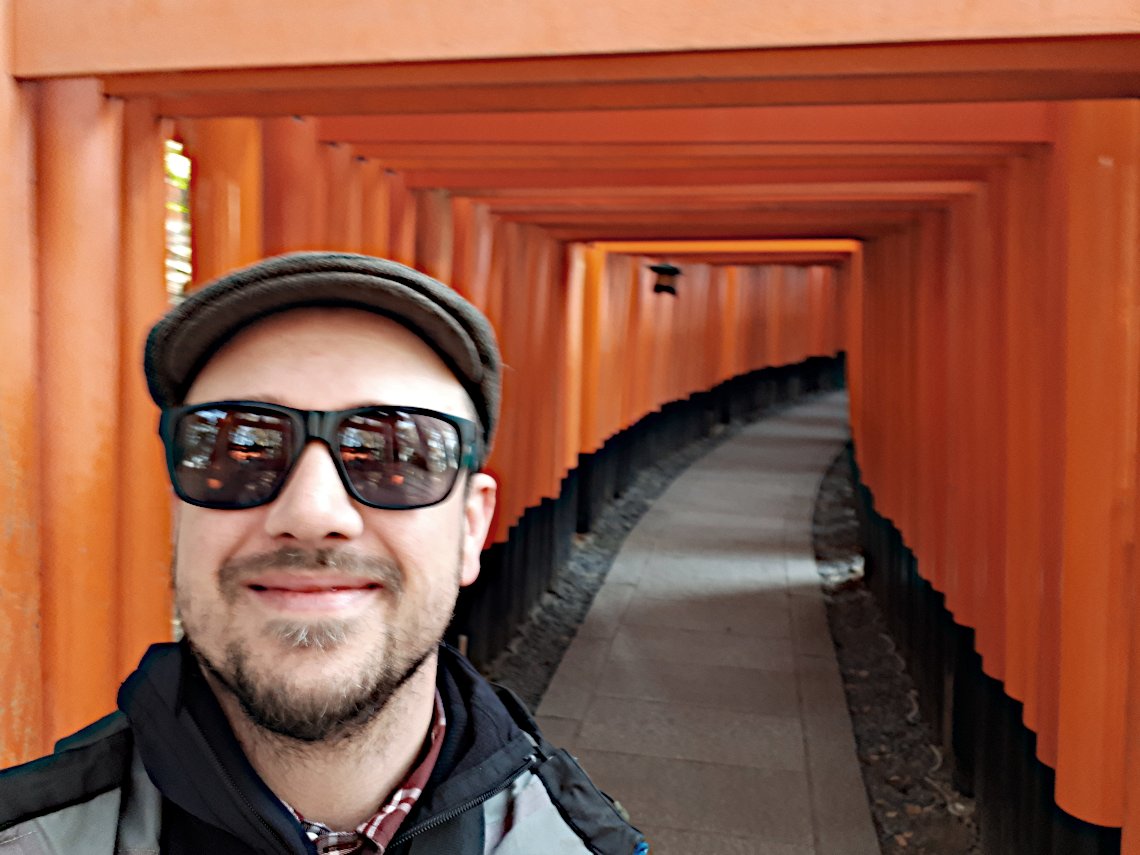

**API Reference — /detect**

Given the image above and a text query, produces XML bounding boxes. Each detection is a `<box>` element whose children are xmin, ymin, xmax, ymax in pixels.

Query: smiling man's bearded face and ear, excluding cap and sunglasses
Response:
<box><xmin>174</xmin><ymin>309</ymin><xmax>495</xmax><ymax>741</ymax></box>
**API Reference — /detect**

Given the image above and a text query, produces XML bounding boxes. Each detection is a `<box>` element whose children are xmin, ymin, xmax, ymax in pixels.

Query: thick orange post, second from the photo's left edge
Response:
<box><xmin>36</xmin><ymin>79</ymin><xmax>129</xmax><ymax>739</ymax></box>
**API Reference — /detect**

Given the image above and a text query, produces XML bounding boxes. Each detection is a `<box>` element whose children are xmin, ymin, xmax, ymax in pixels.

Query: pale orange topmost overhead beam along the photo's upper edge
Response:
<box><xmin>14</xmin><ymin>0</ymin><xmax>1138</xmax><ymax>76</ymax></box>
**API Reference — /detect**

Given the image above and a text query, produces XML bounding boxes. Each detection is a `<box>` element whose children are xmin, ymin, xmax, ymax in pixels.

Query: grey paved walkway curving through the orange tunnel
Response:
<box><xmin>538</xmin><ymin>393</ymin><xmax>879</xmax><ymax>855</ymax></box>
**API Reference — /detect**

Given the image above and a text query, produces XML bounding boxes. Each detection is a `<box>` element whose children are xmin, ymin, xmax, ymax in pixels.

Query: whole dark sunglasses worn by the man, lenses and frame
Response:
<box><xmin>158</xmin><ymin>401</ymin><xmax>478</xmax><ymax>511</ymax></box>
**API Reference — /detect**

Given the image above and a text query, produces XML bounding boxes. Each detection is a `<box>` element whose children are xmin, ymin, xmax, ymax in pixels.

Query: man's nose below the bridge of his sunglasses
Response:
<box><xmin>266</xmin><ymin>441</ymin><xmax>364</xmax><ymax>544</ymax></box>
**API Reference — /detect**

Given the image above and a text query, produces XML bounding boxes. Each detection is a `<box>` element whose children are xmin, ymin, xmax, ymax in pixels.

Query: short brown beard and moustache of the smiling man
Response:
<box><xmin>179</xmin><ymin>549</ymin><xmax>458</xmax><ymax>743</ymax></box>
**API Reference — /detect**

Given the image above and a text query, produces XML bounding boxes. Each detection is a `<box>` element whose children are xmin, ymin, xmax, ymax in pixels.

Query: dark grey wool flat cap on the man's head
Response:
<box><xmin>143</xmin><ymin>252</ymin><xmax>502</xmax><ymax>465</ymax></box>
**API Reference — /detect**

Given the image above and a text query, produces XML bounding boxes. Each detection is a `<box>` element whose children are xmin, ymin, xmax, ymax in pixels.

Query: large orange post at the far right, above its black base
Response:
<box><xmin>1057</xmin><ymin>100</ymin><xmax>1140</xmax><ymax>825</ymax></box>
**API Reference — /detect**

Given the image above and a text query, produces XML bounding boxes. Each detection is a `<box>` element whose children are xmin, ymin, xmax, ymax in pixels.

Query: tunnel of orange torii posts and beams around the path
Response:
<box><xmin>0</xmin><ymin>0</ymin><xmax>1140</xmax><ymax>855</ymax></box>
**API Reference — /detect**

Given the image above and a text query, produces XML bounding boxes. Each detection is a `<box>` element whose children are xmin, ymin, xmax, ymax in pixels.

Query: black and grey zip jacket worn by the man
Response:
<box><xmin>0</xmin><ymin>644</ymin><xmax>649</xmax><ymax>855</ymax></box>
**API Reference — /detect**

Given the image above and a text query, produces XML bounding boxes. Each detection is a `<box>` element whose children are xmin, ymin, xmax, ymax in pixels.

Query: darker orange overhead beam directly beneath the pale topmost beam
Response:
<box><xmin>91</xmin><ymin>35</ymin><xmax>1137</xmax><ymax>95</ymax></box>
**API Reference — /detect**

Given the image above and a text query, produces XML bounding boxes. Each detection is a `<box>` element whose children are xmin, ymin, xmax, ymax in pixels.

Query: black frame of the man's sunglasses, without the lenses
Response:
<box><xmin>158</xmin><ymin>400</ymin><xmax>479</xmax><ymax>511</ymax></box>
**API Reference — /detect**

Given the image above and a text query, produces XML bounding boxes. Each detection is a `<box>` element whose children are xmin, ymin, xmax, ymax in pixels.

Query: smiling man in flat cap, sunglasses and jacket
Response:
<box><xmin>0</xmin><ymin>253</ymin><xmax>648</xmax><ymax>855</ymax></box>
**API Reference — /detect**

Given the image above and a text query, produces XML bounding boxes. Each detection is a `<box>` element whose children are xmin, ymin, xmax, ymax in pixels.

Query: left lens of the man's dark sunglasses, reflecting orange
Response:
<box><xmin>171</xmin><ymin>406</ymin><xmax>294</xmax><ymax>508</ymax></box>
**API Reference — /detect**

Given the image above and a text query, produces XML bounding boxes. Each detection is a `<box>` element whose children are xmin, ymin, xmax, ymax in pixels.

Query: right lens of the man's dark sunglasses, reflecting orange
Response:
<box><xmin>337</xmin><ymin>409</ymin><xmax>462</xmax><ymax>508</ymax></box>
